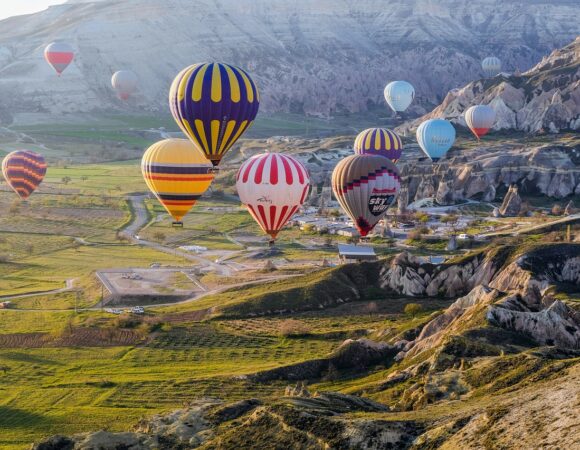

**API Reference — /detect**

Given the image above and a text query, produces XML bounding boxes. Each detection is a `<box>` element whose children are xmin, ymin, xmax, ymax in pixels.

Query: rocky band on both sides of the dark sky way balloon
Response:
<box><xmin>233</xmin><ymin>133</ymin><xmax>580</xmax><ymax>205</ymax></box>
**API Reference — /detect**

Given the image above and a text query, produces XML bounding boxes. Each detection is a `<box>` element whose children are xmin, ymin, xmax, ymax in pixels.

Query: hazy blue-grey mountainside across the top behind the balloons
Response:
<box><xmin>0</xmin><ymin>0</ymin><xmax>580</xmax><ymax>123</ymax></box>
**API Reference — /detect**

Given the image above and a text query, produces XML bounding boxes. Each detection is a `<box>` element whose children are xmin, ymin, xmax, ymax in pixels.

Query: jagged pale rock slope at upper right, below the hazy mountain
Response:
<box><xmin>403</xmin><ymin>36</ymin><xmax>580</xmax><ymax>133</ymax></box>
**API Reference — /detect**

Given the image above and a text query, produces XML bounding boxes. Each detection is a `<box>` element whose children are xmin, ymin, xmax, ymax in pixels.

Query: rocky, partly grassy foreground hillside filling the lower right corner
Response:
<box><xmin>33</xmin><ymin>244</ymin><xmax>580</xmax><ymax>450</ymax></box>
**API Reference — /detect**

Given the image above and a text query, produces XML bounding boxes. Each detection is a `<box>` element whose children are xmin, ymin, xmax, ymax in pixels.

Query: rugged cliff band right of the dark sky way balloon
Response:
<box><xmin>399</xmin><ymin>138</ymin><xmax>580</xmax><ymax>203</ymax></box>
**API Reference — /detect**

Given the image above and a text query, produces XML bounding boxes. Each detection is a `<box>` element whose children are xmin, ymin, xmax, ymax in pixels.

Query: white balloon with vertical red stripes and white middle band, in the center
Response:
<box><xmin>236</xmin><ymin>153</ymin><xmax>310</xmax><ymax>244</ymax></box>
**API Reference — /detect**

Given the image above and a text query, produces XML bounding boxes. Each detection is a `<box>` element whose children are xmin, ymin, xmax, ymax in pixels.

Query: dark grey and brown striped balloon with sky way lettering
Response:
<box><xmin>332</xmin><ymin>154</ymin><xmax>401</xmax><ymax>236</ymax></box>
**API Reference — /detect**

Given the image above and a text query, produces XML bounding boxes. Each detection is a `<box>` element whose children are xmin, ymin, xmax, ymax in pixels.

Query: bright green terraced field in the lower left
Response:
<box><xmin>0</xmin><ymin>313</ymin><xmax>340</xmax><ymax>448</ymax></box>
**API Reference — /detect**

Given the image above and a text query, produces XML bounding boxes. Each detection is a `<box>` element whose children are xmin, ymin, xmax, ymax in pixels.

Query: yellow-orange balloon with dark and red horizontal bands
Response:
<box><xmin>141</xmin><ymin>139</ymin><xmax>214</xmax><ymax>225</ymax></box>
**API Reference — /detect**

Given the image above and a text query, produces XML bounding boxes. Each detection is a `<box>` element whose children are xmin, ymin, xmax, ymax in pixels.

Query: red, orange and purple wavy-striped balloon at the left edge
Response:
<box><xmin>2</xmin><ymin>150</ymin><xmax>46</xmax><ymax>200</ymax></box>
